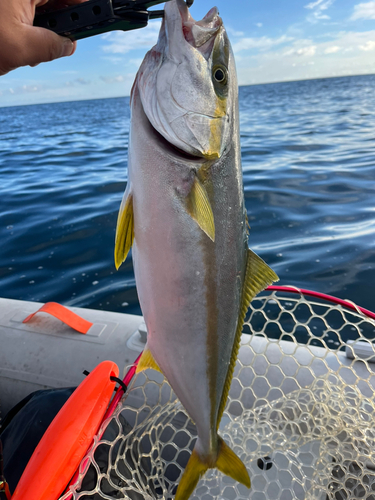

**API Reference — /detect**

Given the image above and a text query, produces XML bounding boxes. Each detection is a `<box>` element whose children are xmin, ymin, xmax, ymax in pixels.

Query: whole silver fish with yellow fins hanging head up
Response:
<box><xmin>115</xmin><ymin>0</ymin><xmax>278</xmax><ymax>500</ymax></box>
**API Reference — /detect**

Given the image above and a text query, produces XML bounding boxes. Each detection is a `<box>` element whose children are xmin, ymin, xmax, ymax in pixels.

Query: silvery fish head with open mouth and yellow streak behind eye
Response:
<box><xmin>136</xmin><ymin>0</ymin><xmax>237</xmax><ymax>160</ymax></box>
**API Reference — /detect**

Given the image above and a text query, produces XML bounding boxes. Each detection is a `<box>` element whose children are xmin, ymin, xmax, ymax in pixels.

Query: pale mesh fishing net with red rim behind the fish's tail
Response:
<box><xmin>62</xmin><ymin>287</ymin><xmax>375</xmax><ymax>500</ymax></box>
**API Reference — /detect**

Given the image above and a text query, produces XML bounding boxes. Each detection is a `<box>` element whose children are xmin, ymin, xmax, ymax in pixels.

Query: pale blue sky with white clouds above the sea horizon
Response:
<box><xmin>0</xmin><ymin>0</ymin><xmax>375</xmax><ymax>107</ymax></box>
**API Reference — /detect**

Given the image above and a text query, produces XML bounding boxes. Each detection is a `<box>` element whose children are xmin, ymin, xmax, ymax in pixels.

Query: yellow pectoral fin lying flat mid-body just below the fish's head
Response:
<box><xmin>188</xmin><ymin>177</ymin><xmax>215</xmax><ymax>241</ymax></box>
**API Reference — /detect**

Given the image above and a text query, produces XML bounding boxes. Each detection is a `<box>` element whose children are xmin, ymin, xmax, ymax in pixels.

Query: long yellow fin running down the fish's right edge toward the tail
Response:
<box><xmin>217</xmin><ymin>249</ymin><xmax>279</xmax><ymax>428</ymax></box>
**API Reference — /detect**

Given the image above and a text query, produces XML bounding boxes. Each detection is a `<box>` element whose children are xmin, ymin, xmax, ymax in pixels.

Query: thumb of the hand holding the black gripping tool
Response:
<box><xmin>19</xmin><ymin>25</ymin><xmax>77</xmax><ymax>66</ymax></box>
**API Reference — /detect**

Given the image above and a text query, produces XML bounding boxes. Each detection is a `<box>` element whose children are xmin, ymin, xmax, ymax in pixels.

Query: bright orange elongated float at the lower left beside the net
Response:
<box><xmin>12</xmin><ymin>361</ymin><xmax>119</xmax><ymax>500</ymax></box>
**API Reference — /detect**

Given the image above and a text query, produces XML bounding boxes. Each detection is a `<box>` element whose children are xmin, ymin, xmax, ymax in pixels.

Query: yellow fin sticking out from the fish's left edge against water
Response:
<box><xmin>115</xmin><ymin>190</ymin><xmax>134</xmax><ymax>269</ymax></box>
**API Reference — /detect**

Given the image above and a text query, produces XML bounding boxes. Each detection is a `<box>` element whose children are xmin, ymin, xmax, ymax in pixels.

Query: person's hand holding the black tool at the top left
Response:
<box><xmin>0</xmin><ymin>0</ymin><xmax>85</xmax><ymax>75</ymax></box>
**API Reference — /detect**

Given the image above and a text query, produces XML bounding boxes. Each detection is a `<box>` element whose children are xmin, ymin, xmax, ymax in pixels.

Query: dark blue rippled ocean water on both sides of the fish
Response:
<box><xmin>0</xmin><ymin>75</ymin><xmax>375</xmax><ymax>314</ymax></box>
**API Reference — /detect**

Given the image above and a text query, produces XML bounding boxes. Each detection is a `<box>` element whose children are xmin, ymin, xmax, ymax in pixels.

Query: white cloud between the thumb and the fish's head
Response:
<box><xmin>101</xmin><ymin>21</ymin><xmax>160</xmax><ymax>54</ymax></box>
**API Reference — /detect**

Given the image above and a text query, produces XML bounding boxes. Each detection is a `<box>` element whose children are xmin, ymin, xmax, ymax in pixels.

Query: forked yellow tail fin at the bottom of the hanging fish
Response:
<box><xmin>175</xmin><ymin>436</ymin><xmax>251</xmax><ymax>500</ymax></box>
